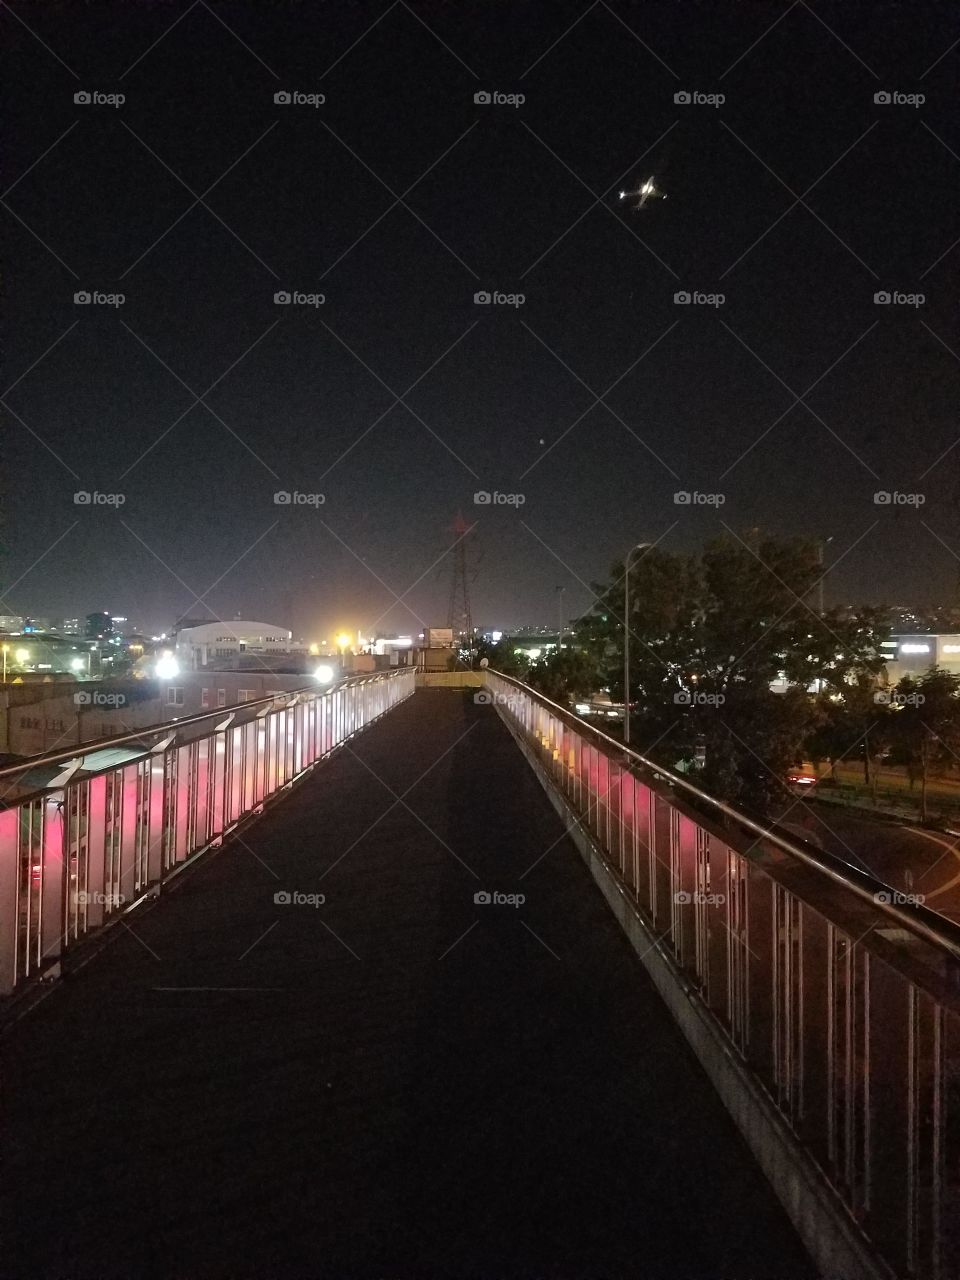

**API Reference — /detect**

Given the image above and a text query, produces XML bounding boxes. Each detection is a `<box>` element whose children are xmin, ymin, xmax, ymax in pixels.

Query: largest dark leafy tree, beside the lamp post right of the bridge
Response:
<box><xmin>579</xmin><ymin>536</ymin><xmax>882</xmax><ymax>810</ymax></box>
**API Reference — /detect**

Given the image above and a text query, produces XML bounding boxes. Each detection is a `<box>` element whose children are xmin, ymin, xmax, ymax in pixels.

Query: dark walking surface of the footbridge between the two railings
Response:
<box><xmin>0</xmin><ymin>691</ymin><xmax>815</xmax><ymax>1280</ymax></box>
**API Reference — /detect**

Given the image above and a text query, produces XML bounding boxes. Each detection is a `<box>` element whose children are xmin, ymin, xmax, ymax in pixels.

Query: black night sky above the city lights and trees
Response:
<box><xmin>0</xmin><ymin>0</ymin><xmax>960</xmax><ymax>637</ymax></box>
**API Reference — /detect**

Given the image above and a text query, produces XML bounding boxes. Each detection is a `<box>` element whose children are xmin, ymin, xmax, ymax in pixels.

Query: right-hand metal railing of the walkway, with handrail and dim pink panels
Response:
<box><xmin>486</xmin><ymin>672</ymin><xmax>960</xmax><ymax>1280</ymax></box>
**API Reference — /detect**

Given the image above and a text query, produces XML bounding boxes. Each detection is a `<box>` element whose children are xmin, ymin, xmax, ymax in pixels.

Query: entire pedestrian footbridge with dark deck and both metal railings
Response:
<box><xmin>0</xmin><ymin>671</ymin><xmax>960</xmax><ymax>1280</ymax></box>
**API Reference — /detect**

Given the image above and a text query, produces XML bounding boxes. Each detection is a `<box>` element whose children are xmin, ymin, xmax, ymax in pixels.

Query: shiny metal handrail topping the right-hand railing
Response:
<box><xmin>489</xmin><ymin>668</ymin><xmax>960</xmax><ymax>960</ymax></box>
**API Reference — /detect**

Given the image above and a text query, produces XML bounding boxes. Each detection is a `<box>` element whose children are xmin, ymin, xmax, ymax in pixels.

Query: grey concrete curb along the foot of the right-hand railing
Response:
<box><xmin>497</xmin><ymin>708</ymin><xmax>895</xmax><ymax>1280</ymax></box>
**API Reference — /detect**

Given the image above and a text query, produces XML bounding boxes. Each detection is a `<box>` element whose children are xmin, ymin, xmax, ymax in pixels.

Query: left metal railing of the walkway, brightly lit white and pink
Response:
<box><xmin>0</xmin><ymin>668</ymin><xmax>413</xmax><ymax>995</ymax></box>
